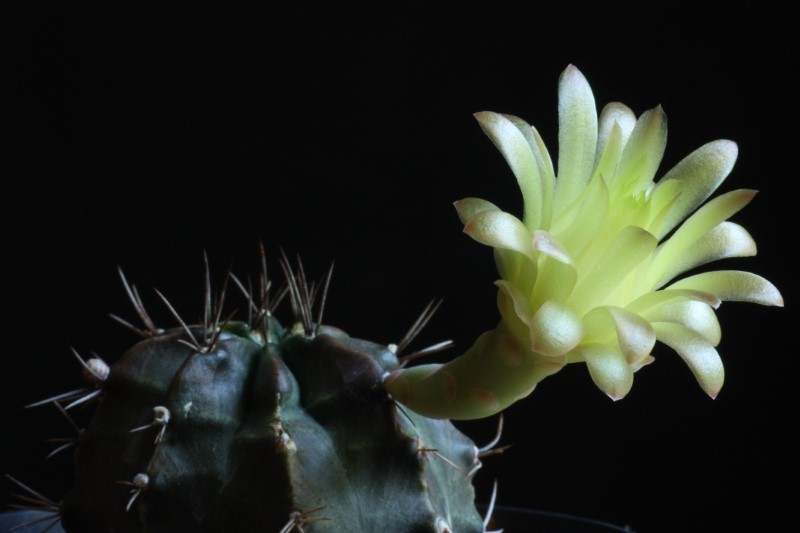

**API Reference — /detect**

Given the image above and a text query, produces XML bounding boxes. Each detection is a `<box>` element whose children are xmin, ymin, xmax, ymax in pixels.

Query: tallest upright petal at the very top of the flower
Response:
<box><xmin>553</xmin><ymin>65</ymin><xmax>597</xmax><ymax>216</ymax></box>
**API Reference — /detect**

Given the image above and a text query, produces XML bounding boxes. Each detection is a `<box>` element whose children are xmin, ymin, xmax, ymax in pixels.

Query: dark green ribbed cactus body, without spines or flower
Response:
<box><xmin>60</xmin><ymin>317</ymin><xmax>484</xmax><ymax>533</ymax></box>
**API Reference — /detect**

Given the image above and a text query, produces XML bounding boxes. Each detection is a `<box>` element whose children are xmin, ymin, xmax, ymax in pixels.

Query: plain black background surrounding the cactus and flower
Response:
<box><xmin>0</xmin><ymin>2</ymin><xmax>798</xmax><ymax>532</ymax></box>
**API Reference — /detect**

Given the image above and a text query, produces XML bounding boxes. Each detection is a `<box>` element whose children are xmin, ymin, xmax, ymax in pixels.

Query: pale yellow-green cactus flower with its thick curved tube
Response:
<box><xmin>385</xmin><ymin>66</ymin><xmax>783</xmax><ymax>419</ymax></box>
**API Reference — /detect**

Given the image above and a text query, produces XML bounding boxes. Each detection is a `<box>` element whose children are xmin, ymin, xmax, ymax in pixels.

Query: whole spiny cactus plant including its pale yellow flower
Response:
<box><xmin>6</xmin><ymin>65</ymin><xmax>783</xmax><ymax>533</ymax></box>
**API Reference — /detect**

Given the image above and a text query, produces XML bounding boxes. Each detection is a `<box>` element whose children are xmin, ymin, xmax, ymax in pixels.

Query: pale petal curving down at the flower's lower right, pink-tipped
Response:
<box><xmin>653</xmin><ymin>322</ymin><xmax>725</xmax><ymax>398</ymax></box>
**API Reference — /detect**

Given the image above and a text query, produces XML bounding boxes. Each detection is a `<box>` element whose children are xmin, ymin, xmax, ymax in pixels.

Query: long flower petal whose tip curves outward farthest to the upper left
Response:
<box><xmin>475</xmin><ymin>111</ymin><xmax>542</xmax><ymax>230</ymax></box>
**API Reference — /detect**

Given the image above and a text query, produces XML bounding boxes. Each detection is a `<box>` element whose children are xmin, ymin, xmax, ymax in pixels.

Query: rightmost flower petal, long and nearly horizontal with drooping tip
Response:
<box><xmin>667</xmin><ymin>270</ymin><xmax>783</xmax><ymax>307</ymax></box>
